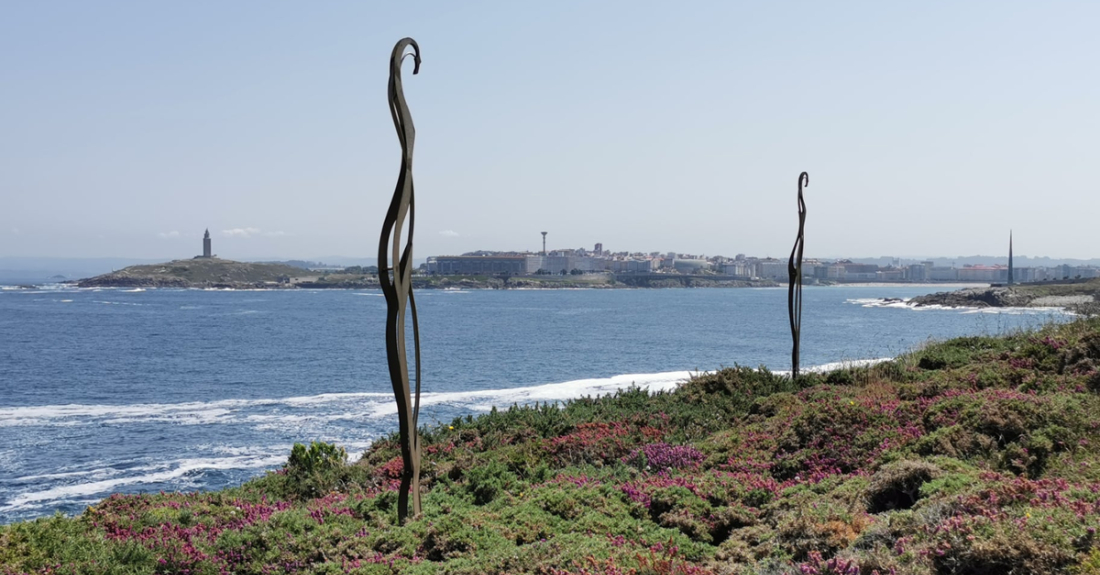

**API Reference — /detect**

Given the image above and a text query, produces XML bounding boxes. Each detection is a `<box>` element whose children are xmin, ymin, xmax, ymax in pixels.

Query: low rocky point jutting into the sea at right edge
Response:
<box><xmin>910</xmin><ymin>279</ymin><xmax>1100</xmax><ymax>311</ymax></box>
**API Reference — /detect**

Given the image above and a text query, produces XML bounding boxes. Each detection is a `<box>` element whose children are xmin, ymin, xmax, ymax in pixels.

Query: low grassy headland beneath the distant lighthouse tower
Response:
<box><xmin>77</xmin><ymin>257</ymin><xmax>311</xmax><ymax>288</ymax></box>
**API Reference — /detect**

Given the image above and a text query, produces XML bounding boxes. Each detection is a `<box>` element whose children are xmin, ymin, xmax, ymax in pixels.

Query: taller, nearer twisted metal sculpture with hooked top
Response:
<box><xmin>378</xmin><ymin>37</ymin><xmax>420</xmax><ymax>522</ymax></box>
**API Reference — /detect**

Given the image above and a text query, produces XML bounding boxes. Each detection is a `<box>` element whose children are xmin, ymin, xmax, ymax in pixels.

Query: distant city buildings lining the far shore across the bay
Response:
<box><xmin>427</xmin><ymin>234</ymin><xmax>1100</xmax><ymax>284</ymax></box>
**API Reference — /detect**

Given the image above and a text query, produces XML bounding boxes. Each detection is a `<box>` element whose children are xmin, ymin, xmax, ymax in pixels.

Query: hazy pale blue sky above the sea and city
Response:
<box><xmin>0</xmin><ymin>1</ymin><xmax>1100</xmax><ymax>258</ymax></box>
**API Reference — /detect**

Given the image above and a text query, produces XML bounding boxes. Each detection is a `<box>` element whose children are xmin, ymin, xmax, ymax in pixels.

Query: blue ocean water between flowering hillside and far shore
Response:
<box><xmin>0</xmin><ymin>286</ymin><xmax>1067</xmax><ymax>523</ymax></box>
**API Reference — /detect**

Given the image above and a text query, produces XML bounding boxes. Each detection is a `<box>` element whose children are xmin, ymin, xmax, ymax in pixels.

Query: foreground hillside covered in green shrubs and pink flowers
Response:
<box><xmin>0</xmin><ymin>319</ymin><xmax>1100</xmax><ymax>575</ymax></box>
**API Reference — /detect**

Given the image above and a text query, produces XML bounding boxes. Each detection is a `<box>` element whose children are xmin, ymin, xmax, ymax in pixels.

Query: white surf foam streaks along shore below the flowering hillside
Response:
<box><xmin>0</xmin><ymin>365</ymin><xmax>902</xmax><ymax>512</ymax></box>
